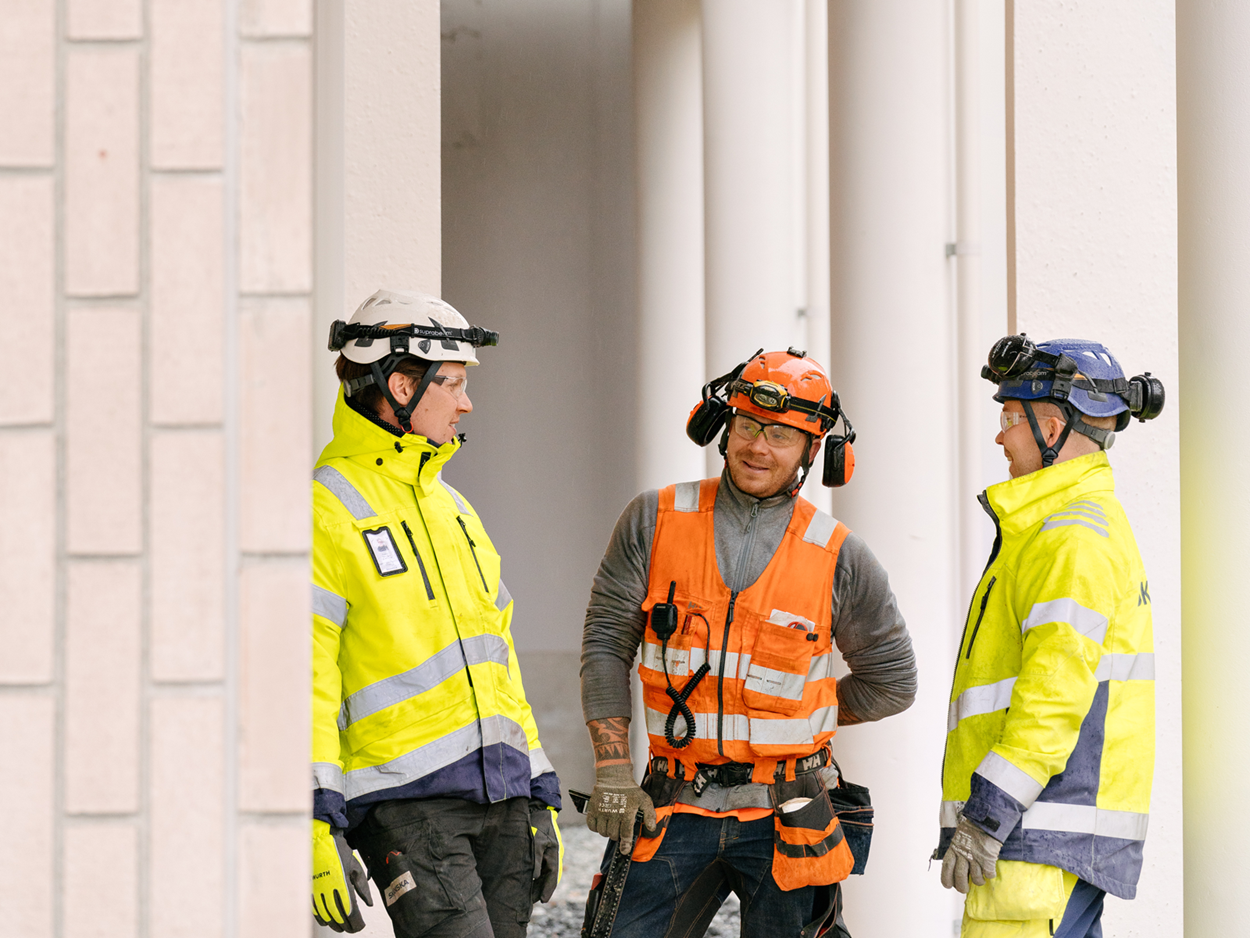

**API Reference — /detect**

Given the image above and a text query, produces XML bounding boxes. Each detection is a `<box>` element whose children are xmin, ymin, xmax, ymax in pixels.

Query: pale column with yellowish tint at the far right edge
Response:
<box><xmin>1175</xmin><ymin>0</ymin><xmax>1250</xmax><ymax>935</ymax></box>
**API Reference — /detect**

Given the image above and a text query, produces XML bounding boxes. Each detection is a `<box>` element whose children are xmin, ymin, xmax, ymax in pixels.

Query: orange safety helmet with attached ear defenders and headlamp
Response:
<box><xmin>686</xmin><ymin>348</ymin><xmax>855</xmax><ymax>494</ymax></box>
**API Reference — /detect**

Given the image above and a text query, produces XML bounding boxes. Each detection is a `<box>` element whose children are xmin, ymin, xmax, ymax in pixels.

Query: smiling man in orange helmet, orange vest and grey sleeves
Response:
<box><xmin>581</xmin><ymin>349</ymin><xmax>916</xmax><ymax>938</ymax></box>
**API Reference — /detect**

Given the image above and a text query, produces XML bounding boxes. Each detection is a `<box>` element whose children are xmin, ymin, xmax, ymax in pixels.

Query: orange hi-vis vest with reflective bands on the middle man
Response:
<box><xmin>639</xmin><ymin>479</ymin><xmax>850</xmax><ymax>784</ymax></box>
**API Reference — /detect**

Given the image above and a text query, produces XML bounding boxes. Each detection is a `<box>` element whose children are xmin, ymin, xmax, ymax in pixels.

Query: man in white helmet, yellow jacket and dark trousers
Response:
<box><xmin>313</xmin><ymin>290</ymin><xmax>564</xmax><ymax>938</ymax></box>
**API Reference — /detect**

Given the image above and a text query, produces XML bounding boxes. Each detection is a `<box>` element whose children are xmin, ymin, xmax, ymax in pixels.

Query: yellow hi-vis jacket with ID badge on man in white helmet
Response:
<box><xmin>313</xmin><ymin>391</ymin><xmax>560</xmax><ymax>827</ymax></box>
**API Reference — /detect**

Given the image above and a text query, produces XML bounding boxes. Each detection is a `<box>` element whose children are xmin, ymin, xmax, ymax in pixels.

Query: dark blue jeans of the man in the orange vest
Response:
<box><xmin>603</xmin><ymin>814</ymin><xmax>816</xmax><ymax>938</ymax></box>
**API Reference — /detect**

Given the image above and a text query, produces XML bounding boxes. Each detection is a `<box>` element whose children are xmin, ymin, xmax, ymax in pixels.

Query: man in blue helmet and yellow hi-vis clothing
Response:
<box><xmin>934</xmin><ymin>334</ymin><xmax>1164</xmax><ymax>938</ymax></box>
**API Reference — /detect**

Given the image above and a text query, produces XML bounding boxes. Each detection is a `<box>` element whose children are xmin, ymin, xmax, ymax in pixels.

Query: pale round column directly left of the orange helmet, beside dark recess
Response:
<box><xmin>633</xmin><ymin>0</ymin><xmax>705</xmax><ymax>489</ymax></box>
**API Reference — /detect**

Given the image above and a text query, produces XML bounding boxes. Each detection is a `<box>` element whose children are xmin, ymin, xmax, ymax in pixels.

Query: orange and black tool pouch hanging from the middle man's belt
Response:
<box><xmin>770</xmin><ymin>773</ymin><xmax>855</xmax><ymax>892</ymax></box>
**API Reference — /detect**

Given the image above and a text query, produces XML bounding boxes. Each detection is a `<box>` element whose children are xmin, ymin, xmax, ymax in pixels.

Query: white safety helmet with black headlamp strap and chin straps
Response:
<box><xmin>329</xmin><ymin>290</ymin><xmax>499</xmax><ymax>433</ymax></box>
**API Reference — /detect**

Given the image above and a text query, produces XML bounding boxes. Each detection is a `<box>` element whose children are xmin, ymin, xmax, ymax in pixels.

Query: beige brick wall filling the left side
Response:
<box><xmin>0</xmin><ymin>0</ymin><xmax>313</xmax><ymax>938</ymax></box>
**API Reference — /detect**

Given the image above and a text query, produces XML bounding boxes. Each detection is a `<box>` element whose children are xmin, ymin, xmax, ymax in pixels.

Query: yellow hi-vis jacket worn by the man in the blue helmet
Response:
<box><xmin>938</xmin><ymin>453</ymin><xmax>1155</xmax><ymax>899</ymax></box>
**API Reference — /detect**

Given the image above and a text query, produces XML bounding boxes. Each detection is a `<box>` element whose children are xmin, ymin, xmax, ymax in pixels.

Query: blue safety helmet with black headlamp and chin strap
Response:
<box><xmin>981</xmin><ymin>333</ymin><xmax>1164</xmax><ymax>466</ymax></box>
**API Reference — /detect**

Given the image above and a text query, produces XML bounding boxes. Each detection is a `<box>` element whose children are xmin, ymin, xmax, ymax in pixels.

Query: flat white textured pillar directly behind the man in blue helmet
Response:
<box><xmin>1010</xmin><ymin>0</ymin><xmax>1175</xmax><ymax>935</ymax></box>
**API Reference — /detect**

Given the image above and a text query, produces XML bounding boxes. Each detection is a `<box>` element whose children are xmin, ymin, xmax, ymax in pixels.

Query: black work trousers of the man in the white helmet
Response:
<box><xmin>348</xmin><ymin>798</ymin><xmax>534</xmax><ymax>938</ymax></box>
